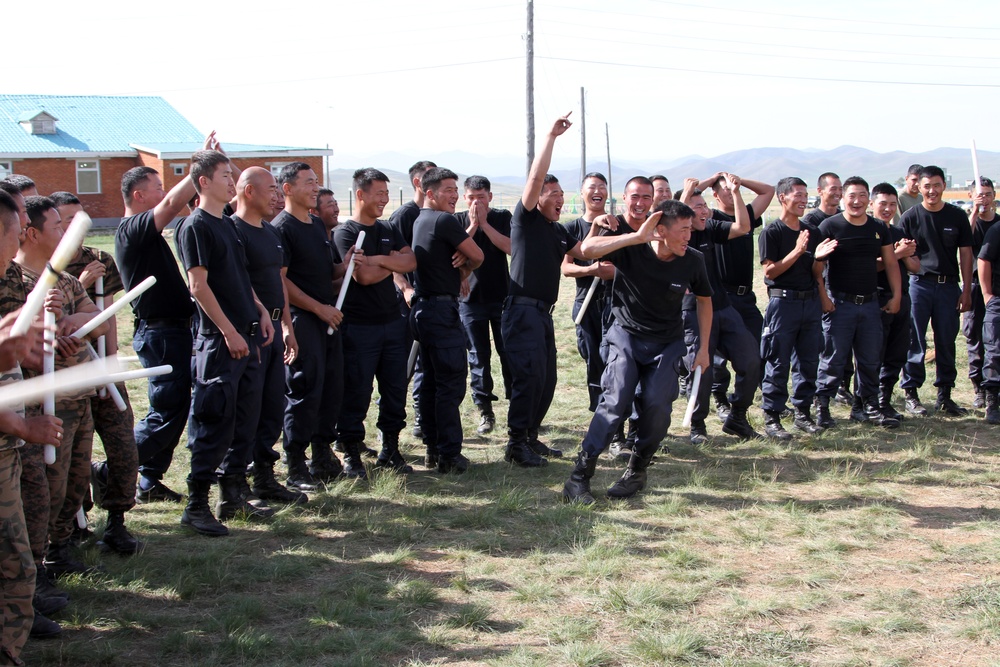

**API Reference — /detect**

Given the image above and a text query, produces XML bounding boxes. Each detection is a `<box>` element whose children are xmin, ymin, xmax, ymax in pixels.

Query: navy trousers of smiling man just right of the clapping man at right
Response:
<box><xmin>816</xmin><ymin>299</ymin><xmax>882</xmax><ymax>403</ymax></box>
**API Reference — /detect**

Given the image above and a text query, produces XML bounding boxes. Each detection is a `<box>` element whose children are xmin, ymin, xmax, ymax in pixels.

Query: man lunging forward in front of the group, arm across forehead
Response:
<box><xmin>563</xmin><ymin>200</ymin><xmax>712</xmax><ymax>504</ymax></box>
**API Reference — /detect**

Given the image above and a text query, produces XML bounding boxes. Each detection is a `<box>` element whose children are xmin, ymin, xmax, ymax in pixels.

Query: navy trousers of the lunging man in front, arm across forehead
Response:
<box><xmin>582</xmin><ymin>324</ymin><xmax>687</xmax><ymax>456</ymax></box>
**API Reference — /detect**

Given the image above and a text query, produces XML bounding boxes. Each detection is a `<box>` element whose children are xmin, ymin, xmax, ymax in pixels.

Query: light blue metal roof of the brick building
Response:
<box><xmin>0</xmin><ymin>95</ymin><xmax>204</xmax><ymax>153</ymax></box>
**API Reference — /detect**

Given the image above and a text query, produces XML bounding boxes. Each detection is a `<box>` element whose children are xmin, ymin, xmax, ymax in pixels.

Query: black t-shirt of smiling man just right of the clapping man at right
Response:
<box><xmin>819</xmin><ymin>213</ymin><xmax>892</xmax><ymax>294</ymax></box>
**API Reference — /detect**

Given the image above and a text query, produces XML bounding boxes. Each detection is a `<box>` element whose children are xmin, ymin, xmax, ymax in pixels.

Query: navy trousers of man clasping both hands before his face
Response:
<box><xmin>458</xmin><ymin>303</ymin><xmax>510</xmax><ymax>410</ymax></box>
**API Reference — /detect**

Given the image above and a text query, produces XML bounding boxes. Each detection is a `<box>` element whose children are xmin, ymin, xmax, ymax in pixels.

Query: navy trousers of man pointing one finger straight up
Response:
<box><xmin>501</xmin><ymin>301</ymin><xmax>556</xmax><ymax>434</ymax></box>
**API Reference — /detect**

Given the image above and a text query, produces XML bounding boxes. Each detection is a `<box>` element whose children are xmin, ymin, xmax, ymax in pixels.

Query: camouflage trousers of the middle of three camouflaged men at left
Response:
<box><xmin>21</xmin><ymin>398</ymin><xmax>94</xmax><ymax>565</ymax></box>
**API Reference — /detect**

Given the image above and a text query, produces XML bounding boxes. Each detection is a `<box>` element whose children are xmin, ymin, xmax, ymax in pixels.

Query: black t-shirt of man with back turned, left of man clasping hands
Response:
<box><xmin>413</xmin><ymin>208</ymin><xmax>469</xmax><ymax>297</ymax></box>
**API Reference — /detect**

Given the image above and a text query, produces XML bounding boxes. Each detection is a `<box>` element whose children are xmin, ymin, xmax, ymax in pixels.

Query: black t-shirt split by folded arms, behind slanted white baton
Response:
<box><xmin>333</xmin><ymin>220</ymin><xmax>407</xmax><ymax>324</ymax></box>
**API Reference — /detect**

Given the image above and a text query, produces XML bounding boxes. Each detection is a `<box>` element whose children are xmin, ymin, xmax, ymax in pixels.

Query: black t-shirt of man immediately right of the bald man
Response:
<box><xmin>271</xmin><ymin>211</ymin><xmax>337</xmax><ymax>306</ymax></box>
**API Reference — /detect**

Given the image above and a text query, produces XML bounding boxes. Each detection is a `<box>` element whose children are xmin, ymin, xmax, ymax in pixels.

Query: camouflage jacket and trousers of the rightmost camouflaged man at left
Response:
<box><xmin>66</xmin><ymin>246</ymin><xmax>139</xmax><ymax>512</ymax></box>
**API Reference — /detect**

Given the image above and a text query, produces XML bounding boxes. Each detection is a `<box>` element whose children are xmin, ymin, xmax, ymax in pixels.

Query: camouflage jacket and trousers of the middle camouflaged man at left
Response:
<box><xmin>21</xmin><ymin>266</ymin><xmax>96</xmax><ymax>565</ymax></box>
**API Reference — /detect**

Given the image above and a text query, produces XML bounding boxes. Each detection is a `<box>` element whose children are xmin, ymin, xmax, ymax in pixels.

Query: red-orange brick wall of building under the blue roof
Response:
<box><xmin>6</xmin><ymin>153</ymin><xmax>323</xmax><ymax>219</ymax></box>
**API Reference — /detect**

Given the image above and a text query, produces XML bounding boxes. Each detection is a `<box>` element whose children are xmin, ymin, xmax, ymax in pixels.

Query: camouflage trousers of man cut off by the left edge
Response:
<box><xmin>0</xmin><ymin>449</ymin><xmax>35</xmax><ymax>664</ymax></box>
